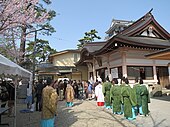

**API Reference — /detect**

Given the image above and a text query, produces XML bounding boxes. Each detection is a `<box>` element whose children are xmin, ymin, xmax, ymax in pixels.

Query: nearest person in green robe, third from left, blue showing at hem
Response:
<box><xmin>121</xmin><ymin>78</ymin><xmax>137</xmax><ymax>120</ymax></box>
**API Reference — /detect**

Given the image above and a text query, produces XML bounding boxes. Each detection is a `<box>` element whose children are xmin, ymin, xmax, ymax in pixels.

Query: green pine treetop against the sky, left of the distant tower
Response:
<box><xmin>77</xmin><ymin>29</ymin><xmax>101</xmax><ymax>49</ymax></box>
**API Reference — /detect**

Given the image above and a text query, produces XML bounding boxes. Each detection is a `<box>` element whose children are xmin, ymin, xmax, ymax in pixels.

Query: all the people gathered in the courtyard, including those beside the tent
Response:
<box><xmin>0</xmin><ymin>77</ymin><xmax>150</xmax><ymax>127</ymax></box>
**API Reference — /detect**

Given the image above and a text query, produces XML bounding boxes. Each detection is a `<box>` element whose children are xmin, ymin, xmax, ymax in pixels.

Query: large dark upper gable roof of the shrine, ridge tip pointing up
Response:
<box><xmin>93</xmin><ymin>10</ymin><xmax>170</xmax><ymax>55</ymax></box>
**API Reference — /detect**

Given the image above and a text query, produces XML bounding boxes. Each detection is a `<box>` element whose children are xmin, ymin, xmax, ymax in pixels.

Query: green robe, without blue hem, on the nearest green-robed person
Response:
<box><xmin>121</xmin><ymin>85</ymin><xmax>137</xmax><ymax>118</ymax></box>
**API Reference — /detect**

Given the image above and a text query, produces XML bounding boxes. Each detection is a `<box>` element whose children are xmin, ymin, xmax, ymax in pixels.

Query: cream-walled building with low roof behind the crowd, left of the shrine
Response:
<box><xmin>38</xmin><ymin>50</ymin><xmax>87</xmax><ymax>80</ymax></box>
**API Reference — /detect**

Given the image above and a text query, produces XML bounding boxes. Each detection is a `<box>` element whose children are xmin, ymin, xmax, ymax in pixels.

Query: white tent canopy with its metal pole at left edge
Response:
<box><xmin>0</xmin><ymin>54</ymin><xmax>32</xmax><ymax>127</ymax></box>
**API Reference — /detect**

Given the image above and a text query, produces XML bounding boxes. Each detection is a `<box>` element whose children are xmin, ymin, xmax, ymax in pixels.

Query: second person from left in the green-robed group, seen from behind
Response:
<box><xmin>110</xmin><ymin>78</ymin><xmax>123</xmax><ymax>115</ymax></box>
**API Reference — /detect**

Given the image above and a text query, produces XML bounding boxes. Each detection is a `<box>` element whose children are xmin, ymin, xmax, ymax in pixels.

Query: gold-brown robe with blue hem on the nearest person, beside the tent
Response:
<box><xmin>41</xmin><ymin>86</ymin><xmax>58</xmax><ymax>127</ymax></box>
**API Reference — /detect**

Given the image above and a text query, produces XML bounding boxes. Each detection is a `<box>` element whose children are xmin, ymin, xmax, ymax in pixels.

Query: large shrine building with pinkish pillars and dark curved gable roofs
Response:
<box><xmin>76</xmin><ymin>11</ymin><xmax>170</xmax><ymax>87</ymax></box>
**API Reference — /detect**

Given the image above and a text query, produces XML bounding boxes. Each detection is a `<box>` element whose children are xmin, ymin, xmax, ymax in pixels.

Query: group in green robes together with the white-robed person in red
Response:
<box><xmin>87</xmin><ymin>77</ymin><xmax>150</xmax><ymax>120</ymax></box>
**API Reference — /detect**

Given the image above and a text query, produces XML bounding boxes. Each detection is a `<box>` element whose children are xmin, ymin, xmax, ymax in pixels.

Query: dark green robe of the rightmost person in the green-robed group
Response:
<box><xmin>141</xmin><ymin>85</ymin><xmax>150</xmax><ymax>115</ymax></box>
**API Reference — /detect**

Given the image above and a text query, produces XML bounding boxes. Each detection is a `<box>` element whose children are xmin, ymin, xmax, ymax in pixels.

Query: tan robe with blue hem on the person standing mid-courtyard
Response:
<box><xmin>66</xmin><ymin>84</ymin><xmax>74</xmax><ymax>107</ymax></box>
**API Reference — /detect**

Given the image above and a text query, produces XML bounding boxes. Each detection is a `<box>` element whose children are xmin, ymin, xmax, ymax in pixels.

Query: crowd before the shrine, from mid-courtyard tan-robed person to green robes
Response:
<box><xmin>39</xmin><ymin>77</ymin><xmax>150</xmax><ymax>126</ymax></box>
